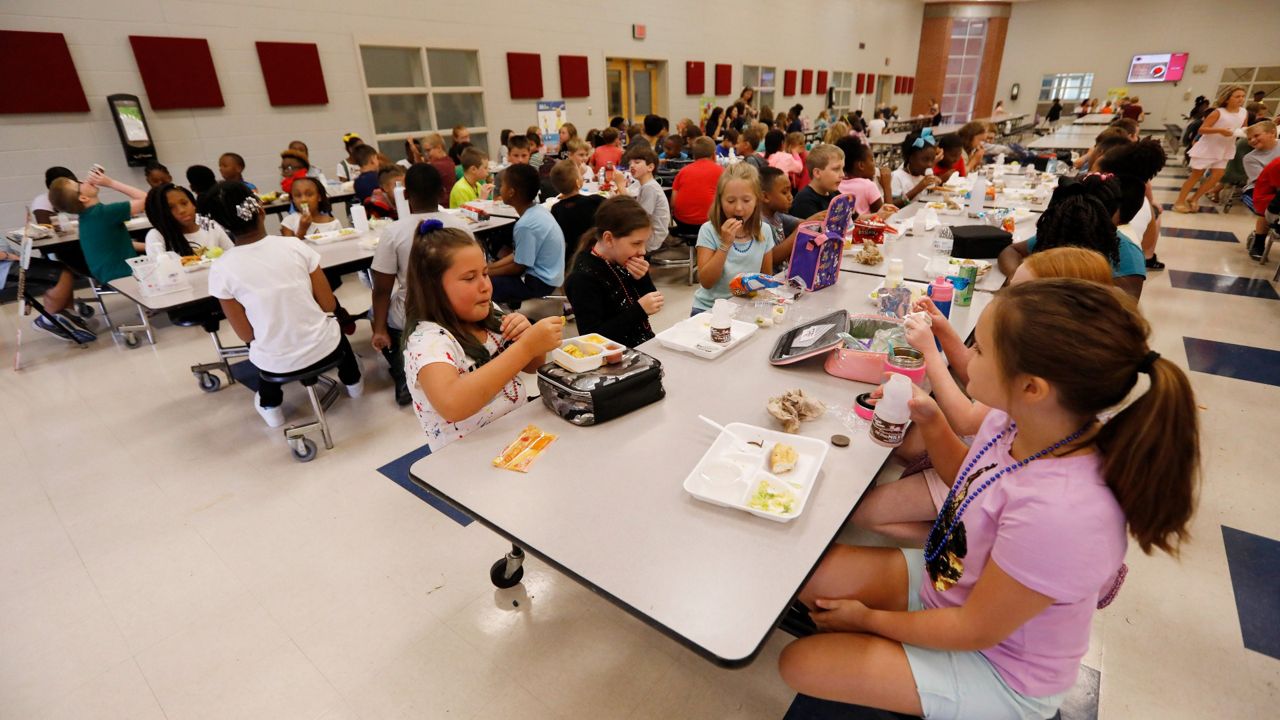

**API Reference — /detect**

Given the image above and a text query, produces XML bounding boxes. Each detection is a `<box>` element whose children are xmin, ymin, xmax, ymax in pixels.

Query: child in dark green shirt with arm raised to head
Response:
<box><xmin>49</xmin><ymin>170</ymin><xmax>147</xmax><ymax>283</ymax></box>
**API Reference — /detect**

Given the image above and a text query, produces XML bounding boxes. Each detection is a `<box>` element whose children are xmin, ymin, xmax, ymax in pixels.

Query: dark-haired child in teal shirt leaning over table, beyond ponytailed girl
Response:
<box><xmin>997</xmin><ymin>174</ymin><xmax>1147</xmax><ymax>300</ymax></box>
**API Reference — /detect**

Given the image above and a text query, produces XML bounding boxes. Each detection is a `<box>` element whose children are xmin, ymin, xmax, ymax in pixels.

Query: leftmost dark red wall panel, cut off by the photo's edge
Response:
<box><xmin>0</xmin><ymin>29</ymin><xmax>88</xmax><ymax>114</ymax></box>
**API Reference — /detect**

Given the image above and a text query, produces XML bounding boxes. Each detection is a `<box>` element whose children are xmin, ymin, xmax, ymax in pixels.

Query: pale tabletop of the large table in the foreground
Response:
<box><xmin>411</xmin><ymin>273</ymin><xmax>972</xmax><ymax>665</ymax></box>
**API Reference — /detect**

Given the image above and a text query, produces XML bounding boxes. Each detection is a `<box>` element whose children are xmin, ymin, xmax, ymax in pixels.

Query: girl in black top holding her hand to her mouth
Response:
<box><xmin>564</xmin><ymin>193</ymin><xmax>663</xmax><ymax>347</ymax></box>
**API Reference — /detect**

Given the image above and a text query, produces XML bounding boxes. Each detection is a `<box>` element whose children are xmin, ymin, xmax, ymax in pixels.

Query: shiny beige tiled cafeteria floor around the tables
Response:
<box><xmin>0</xmin><ymin>163</ymin><xmax>1280</xmax><ymax>720</ymax></box>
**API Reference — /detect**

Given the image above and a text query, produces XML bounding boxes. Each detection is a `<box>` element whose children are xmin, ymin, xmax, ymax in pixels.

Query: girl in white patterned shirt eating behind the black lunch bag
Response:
<box><xmin>404</xmin><ymin>219</ymin><xmax>564</xmax><ymax>452</ymax></box>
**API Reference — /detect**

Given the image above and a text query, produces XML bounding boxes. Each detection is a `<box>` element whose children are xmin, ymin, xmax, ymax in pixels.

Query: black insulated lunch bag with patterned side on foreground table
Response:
<box><xmin>538</xmin><ymin>348</ymin><xmax>667</xmax><ymax>425</ymax></box>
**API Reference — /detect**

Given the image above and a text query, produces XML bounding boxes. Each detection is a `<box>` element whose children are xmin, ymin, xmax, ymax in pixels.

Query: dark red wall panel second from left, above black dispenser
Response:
<box><xmin>129</xmin><ymin>35</ymin><xmax>223</xmax><ymax>110</ymax></box>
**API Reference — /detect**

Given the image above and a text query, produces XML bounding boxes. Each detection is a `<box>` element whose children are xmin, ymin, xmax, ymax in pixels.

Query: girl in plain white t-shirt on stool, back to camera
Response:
<box><xmin>207</xmin><ymin>182</ymin><xmax>365</xmax><ymax>428</ymax></box>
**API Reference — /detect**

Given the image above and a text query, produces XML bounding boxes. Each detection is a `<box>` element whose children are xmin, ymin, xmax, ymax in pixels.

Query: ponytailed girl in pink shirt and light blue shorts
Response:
<box><xmin>780</xmin><ymin>278</ymin><xmax>1199</xmax><ymax>719</ymax></box>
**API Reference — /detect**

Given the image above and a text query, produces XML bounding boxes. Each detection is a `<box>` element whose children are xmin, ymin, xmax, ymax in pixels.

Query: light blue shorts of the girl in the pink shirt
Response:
<box><xmin>902</xmin><ymin>547</ymin><xmax>1066</xmax><ymax>720</ymax></box>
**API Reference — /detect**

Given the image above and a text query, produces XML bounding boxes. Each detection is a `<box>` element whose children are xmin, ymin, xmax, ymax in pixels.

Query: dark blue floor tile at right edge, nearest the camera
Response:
<box><xmin>1222</xmin><ymin>525</ymin><xmax>1280</xmax><ymax>660</ymax></box>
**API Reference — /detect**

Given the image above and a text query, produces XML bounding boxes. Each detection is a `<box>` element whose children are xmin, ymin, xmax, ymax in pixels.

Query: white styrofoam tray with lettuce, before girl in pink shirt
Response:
<box><xmin>684</xmin><ymin>423</ymin><xmax>827</xmax><ymax>523</ymax></box>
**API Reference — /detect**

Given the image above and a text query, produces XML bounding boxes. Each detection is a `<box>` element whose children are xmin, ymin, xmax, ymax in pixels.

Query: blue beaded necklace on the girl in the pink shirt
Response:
<box><xmin>924</xmin><ymin>423</ymin><xmax>1089</xmax><ymax>592</ymax></box>
